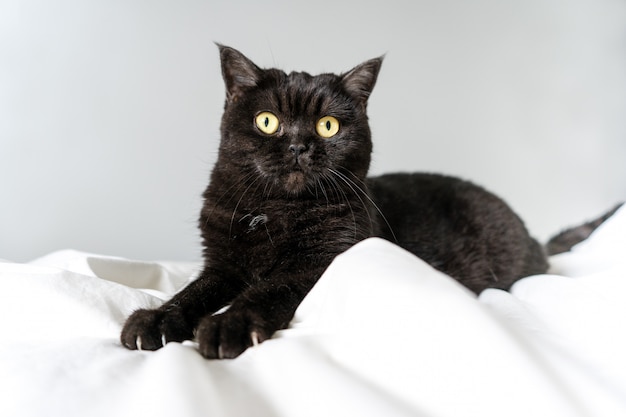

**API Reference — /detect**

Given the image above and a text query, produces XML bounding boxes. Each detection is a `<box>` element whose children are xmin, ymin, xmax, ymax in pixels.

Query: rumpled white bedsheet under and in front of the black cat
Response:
<box><xmin>0</xmin><ymin>209</ymin><xmax>626</xmax><ymax>417</ymax></box>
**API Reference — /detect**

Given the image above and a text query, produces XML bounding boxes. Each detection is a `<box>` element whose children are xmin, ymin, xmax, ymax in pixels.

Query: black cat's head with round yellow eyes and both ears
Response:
<box><xmin>218</xmin><ymin>45</ymin><xmax>382</xmax><ymax>194</ymax></box>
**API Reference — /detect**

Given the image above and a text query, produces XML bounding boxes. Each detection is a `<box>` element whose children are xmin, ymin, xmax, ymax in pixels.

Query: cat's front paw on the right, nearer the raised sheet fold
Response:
<box><xmin>196</xmin><ymin>310</ymin><xmax>274</xmax><ymax>359</ymax></box>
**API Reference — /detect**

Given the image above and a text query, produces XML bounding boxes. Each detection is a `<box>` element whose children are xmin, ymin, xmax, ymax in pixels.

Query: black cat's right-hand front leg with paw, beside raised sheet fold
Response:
<box><xmin>196</xmin><ymin>269</ymin><xmax>323</xmax><ymax>359</ymax></box>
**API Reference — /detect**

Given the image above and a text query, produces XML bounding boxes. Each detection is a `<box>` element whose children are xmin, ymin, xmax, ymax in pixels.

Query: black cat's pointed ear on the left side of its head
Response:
<box><xmin>217</xmin><ymin>44</ymin><xmax>263</xmax><ymax>101</ymax></box>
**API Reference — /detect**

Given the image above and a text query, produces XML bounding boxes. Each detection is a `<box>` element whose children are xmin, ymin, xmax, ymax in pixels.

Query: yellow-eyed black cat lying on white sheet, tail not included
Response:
<box><xmin>121</xmin><ymin>46</ymin><xmax>608</xmax><ymax>358</ymax></box>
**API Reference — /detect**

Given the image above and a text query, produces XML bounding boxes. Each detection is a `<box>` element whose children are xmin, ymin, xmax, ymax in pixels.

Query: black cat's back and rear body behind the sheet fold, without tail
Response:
<box><xmin>368</xmin><ymin>173</ymin><xmax>547</xmax><ymax>292</ymax></box>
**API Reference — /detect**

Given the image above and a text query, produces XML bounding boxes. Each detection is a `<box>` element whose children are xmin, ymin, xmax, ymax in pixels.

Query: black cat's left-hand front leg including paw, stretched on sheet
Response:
<box><xmin>120</xmin><ymin>271</ymin><xmax>237</xmax><ymax>350</ymax></box>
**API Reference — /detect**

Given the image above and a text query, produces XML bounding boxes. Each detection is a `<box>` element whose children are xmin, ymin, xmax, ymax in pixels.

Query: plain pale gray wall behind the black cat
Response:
<box><xmin>0</xmin><ymin>0</ymin><xmax>626</xmax><ymax>261</ymax></box>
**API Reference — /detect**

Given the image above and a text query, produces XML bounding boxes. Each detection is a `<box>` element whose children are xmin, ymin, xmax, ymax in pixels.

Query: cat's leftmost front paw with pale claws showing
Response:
<box><xmin>120</xmin><ymin>310</ymin><xmax>193</xmax><ymax>350</ymax></box>
